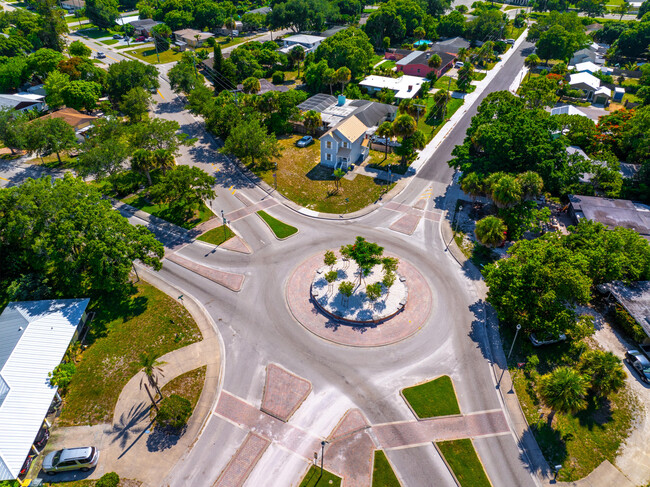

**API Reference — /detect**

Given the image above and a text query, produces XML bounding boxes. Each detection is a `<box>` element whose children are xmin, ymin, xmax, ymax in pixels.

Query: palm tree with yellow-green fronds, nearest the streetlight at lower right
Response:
<box><xmin>539</xmin><ymin>367</ymin><xmax>589</xmax><ymax>422</ymax></box>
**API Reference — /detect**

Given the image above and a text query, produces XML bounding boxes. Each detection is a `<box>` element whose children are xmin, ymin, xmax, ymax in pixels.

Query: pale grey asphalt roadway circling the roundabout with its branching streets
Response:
<box><xmin>0</xmin><ymin>31</ymin><xmax>535</xmax><ymax>487</ymax></box>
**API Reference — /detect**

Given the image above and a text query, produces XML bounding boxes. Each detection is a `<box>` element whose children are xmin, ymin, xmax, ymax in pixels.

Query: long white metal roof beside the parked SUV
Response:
<box><xmin>0</xmin><ymin>299</ymin><xmax>89</xmax><ymax>480</ymax></box>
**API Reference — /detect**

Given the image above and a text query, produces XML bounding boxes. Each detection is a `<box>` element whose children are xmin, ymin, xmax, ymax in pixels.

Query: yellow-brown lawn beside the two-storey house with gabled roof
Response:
<box><xmin>251</xmin><ymin>135</ymin><xmax>390</xmax><ymax>213</ymax></box>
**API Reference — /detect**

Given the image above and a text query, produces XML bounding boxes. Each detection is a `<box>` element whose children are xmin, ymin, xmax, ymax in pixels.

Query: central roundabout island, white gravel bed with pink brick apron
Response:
<box><xmin>286</xmin><ymin>240</ymin><xmax>433</xmax><ymax>347</ymax></box>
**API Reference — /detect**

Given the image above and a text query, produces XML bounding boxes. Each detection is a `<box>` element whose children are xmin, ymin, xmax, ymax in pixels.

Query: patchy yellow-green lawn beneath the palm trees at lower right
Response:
<box><xmin>501</xmin><ymin>327</ymin><xmax>638</xmax><ymax>482</ymax></box>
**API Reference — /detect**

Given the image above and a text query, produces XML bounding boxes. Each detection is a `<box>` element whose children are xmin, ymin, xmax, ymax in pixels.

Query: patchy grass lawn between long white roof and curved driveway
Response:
<box><xmin>59</xmin><ymin>281</ymin><xmax>201</xmax><ymax>426</ymax></box>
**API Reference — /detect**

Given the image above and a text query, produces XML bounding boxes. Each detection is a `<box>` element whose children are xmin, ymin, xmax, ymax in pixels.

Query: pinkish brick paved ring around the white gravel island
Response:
<box><xmin>286</xmin><ymin>251</ymin><xmax>433</xmax><ymax>347</ymax></box>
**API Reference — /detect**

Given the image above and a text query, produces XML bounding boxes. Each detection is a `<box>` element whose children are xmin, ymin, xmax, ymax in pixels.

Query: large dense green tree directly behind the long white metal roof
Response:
<box><xmin>0</xmin><ymin>174</ymin><xmax>163</xmax><ymax>302</ymax></box>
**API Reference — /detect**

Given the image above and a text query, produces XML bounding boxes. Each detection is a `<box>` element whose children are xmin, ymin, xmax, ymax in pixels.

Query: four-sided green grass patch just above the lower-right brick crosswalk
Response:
<box><xmin>402</xmin><ymin>375</ymin><xmax>460</xmax><ymax>418</ymax></box>
